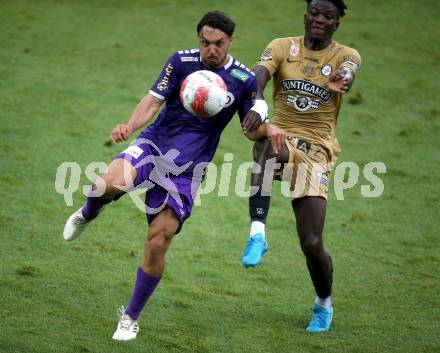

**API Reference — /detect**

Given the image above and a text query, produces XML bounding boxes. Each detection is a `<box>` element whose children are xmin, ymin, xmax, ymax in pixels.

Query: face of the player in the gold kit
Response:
<box><xmin>304</xmin><ymin>0</ymin><xmax>339</xmax><ymax>41</ymax></box>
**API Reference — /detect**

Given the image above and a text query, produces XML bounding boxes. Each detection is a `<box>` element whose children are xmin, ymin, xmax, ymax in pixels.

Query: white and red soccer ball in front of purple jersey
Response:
<box><xmin>180</xmin><ymin>70</ymin><xmax>228</xmax><ymax>117</ymax></box>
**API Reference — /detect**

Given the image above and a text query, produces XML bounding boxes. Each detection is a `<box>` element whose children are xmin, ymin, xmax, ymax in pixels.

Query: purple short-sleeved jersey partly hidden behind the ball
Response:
<box><xmin>139</xmin><ymin>49</ymin><xmax>256</xmax><ymax>174</ymax></box>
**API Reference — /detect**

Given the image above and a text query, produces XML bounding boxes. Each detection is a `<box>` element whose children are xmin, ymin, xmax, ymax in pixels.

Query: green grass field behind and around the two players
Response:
<box><xmin>0</xmin><ymin>0</ymin><xmax>440</xmax><ymax>353</ymax></box>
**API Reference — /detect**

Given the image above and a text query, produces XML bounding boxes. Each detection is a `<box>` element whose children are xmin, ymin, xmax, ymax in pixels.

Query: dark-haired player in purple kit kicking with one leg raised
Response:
<box><xmin>64</xmin><ymin>11</ymin><xmax>262</xmax><ymax>340</ymax></box>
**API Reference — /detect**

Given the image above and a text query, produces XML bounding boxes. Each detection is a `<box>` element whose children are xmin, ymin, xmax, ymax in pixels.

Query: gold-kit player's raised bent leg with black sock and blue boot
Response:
<box><xmin>241</xmin><ymin>138</ymin><xmax>289</xmax><ymax>267</ymax></box>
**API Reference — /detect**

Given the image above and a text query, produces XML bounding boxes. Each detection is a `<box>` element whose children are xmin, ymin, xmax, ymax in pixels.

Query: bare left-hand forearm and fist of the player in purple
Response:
<box><xmin>110</xmin><ymin>93</ymin><xmax>163</xmax><ymax>143</ymax></box>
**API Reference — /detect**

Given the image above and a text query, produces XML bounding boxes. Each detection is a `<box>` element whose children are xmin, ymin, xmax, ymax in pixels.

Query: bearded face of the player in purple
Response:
<box><xmin>199</xmin><ymin>26</ymin><xmax>232</xmax><ymax>69</ymax></box>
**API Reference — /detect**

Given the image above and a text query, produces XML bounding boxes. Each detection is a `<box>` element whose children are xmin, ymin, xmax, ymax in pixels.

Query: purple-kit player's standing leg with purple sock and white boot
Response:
<box><xmin>113</xmin><ymin>207</ymin><xmax>180</xmax><ymax>341</ymax></box>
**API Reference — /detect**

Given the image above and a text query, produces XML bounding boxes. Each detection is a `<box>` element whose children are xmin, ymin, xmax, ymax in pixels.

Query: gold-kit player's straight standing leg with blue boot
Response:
<box><xmin>292</xmin><ymin>196</ymin><xmax>333</xmax><ymax>332</ymax></box>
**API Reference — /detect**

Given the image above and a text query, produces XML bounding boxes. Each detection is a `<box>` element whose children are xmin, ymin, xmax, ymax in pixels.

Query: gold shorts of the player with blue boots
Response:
<box><xmin>279</xmin><ymin>135</ymin><xmax>335</xmax><ymax>200</ymax></box>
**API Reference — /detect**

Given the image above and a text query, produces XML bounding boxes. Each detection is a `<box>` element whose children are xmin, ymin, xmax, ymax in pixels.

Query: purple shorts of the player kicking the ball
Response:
<box><xmin>114</xmin><ymin>138</ymin><xmax>201</xmax><ymax>232</ymax></box>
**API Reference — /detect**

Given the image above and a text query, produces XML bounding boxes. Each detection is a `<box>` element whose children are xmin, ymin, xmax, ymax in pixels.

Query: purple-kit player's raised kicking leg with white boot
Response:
<box><xmin>63</xmin><ymin>158</ymin><xmax>136</xmax><ymax>240</ymax></box>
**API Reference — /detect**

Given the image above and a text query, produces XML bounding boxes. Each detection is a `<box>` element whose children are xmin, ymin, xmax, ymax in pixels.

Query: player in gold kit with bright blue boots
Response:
<box><xmin>242</xmin><ymin>0</ymin><xmax>361</xmax><ymax>332</ymax></box>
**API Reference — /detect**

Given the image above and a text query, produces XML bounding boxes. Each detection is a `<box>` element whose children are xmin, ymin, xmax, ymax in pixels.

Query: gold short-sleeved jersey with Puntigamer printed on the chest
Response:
<box><xmin>256</xmin><ymin>37</ymin><xmax>361</xmax><ymax>160</ymax></box>
